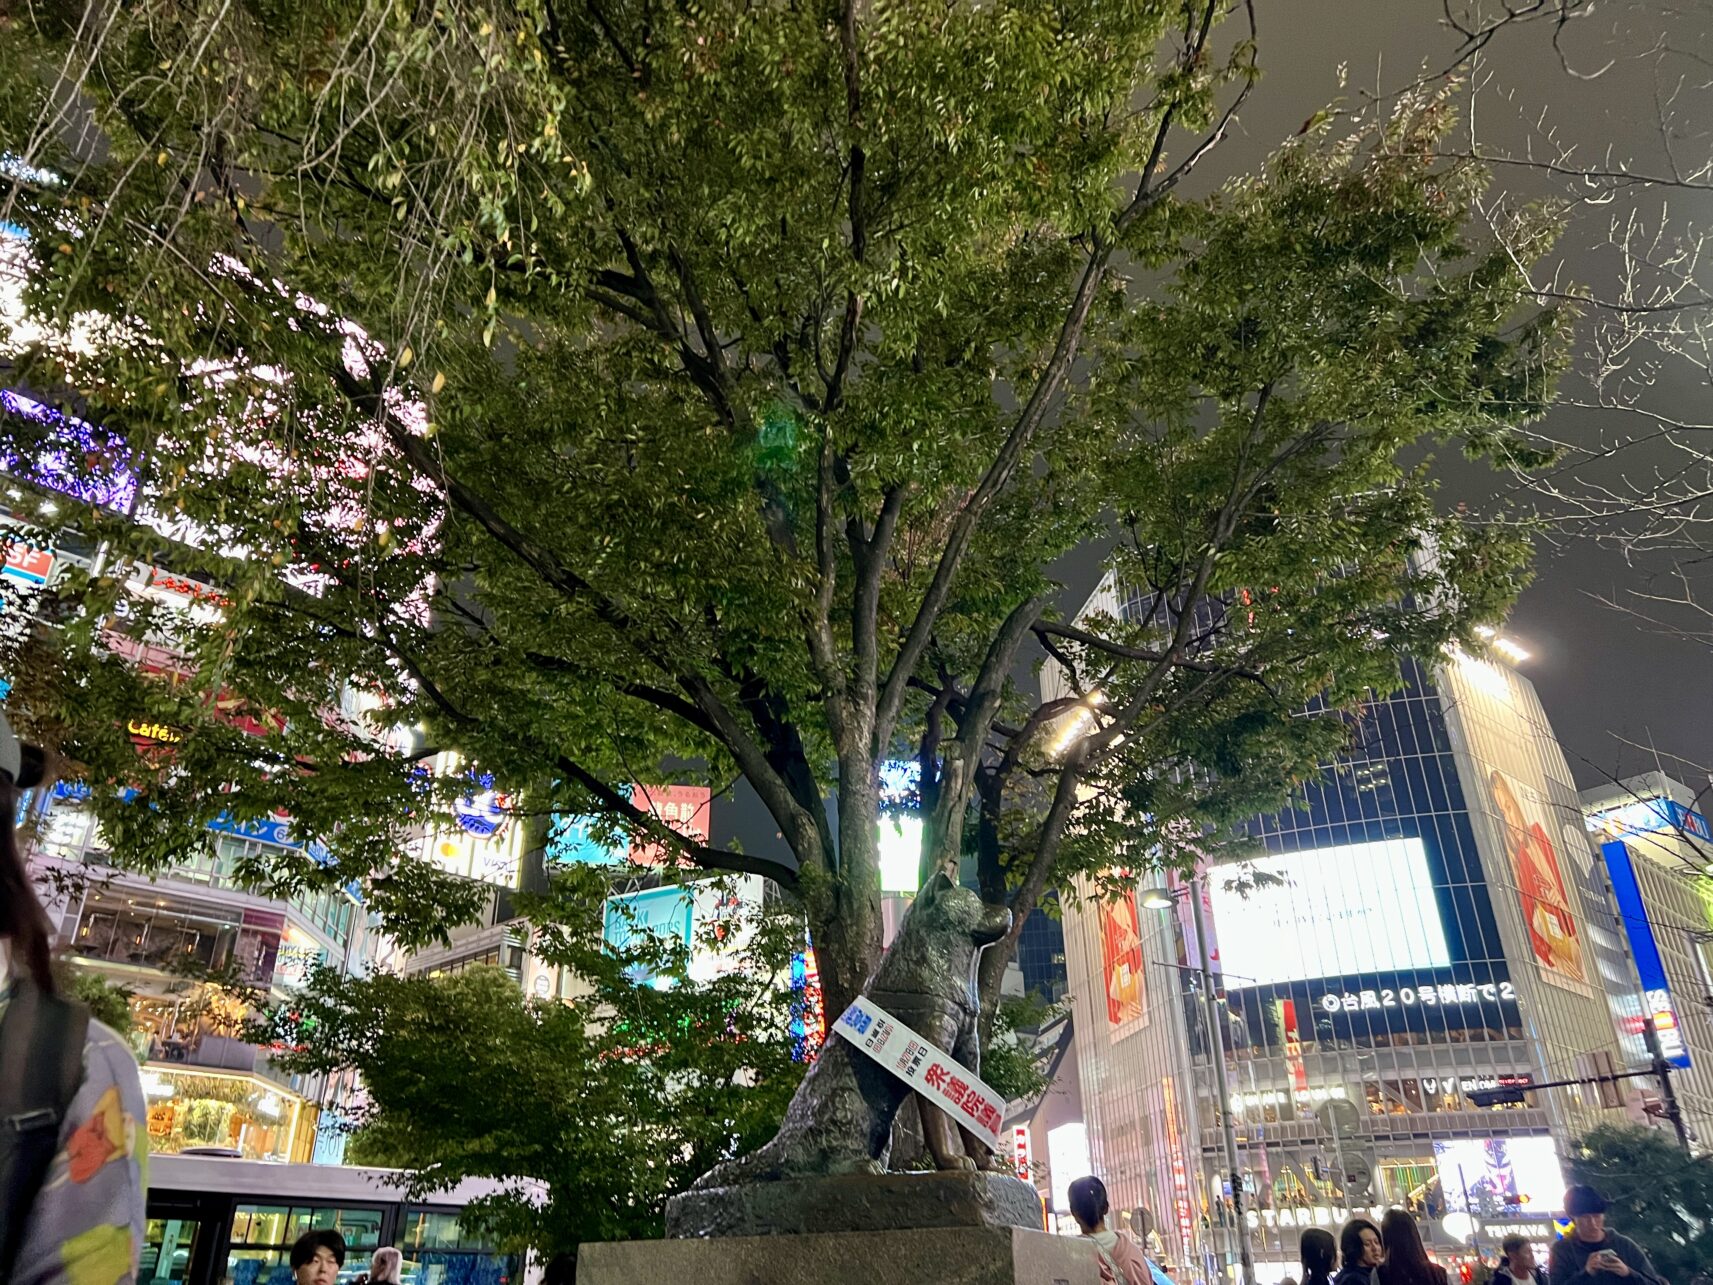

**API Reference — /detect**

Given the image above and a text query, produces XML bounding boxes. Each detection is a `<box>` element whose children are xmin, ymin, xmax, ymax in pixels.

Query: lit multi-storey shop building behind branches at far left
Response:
<box><xmin>0</xmin><ymin>520</ymin><xmax>375</xmax><ymax>1160</ymax></box>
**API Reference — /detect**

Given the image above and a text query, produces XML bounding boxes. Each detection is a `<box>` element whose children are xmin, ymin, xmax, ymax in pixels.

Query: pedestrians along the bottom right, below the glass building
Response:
<box><xmin>1068</xmin><ymin>1177</ymin><xmax>1671</xmax><ymax>1285</ymax></box>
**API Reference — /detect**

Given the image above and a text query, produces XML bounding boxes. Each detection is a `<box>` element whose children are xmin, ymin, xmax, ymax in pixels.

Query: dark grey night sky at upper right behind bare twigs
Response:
<box><xmin>1151</xmin><ymin>0</ymin><xmax>1713</xmax><ymax>788</ymax></box>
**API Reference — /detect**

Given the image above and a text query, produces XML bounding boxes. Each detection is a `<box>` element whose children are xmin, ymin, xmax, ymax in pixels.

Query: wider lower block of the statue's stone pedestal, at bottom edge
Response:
<box><xmin>577</xmin><ymin>1227</ymin><xmax>1100</xmax><ymax>1285</ymax></box>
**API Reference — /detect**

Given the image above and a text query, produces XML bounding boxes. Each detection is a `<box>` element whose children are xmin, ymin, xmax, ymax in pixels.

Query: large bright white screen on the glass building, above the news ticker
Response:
<box><xmin>1208</xmin><ymin>838</ymin><xmax>1451</xmax><ymax>987</ymax></box>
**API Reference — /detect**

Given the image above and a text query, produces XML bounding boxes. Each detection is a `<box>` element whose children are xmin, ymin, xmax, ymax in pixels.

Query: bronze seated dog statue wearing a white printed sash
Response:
<box><xmin>695</xmin><ymin>874</ymin><xmax>1011</xmax><ymax>1189</ymax></box>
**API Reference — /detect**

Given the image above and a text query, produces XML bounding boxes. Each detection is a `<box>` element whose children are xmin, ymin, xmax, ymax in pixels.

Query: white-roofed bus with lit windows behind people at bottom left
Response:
<box><xmin>137</xmin><ymin>1155</ymin><xmax>545</xmax><ymax>1285</ymax></box>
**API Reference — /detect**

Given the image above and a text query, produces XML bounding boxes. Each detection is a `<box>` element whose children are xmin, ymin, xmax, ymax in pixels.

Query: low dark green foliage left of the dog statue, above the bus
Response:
<box><xmin>252</xmin><ymin>888</ymin><xmax>803</xmax><ymax>1252</ymax></box>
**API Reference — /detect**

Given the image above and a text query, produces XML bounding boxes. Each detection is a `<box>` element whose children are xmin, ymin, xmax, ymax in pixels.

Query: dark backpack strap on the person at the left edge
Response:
<box><xmin>0</xmin><ymin>977</ymin><xmax>89</xmax><ymax>1283</ymax></box>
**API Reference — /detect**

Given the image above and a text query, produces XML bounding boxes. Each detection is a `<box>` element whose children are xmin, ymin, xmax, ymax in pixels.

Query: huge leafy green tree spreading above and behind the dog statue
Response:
<box><xmin>0</xmin><ymin>0</ymin><xmax>1561</xmax><ymax>1011</ymax></box>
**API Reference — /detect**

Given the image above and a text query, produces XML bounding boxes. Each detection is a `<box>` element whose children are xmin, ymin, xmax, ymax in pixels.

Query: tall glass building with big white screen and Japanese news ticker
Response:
<box><xmin>1048</xmin><ymin>586</ymin><xmax>1636</xmax><ymax>1282</ymax></box>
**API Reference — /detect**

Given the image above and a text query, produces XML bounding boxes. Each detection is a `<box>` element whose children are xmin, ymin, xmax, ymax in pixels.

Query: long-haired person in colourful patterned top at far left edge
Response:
<box><xmin>0</xmin><ymin>714</ymin><xmax>149</xmax><ymax>1285</ymax></box>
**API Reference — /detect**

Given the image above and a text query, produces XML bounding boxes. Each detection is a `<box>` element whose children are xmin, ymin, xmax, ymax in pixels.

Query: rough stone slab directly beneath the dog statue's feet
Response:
<box><xmin>666</xmin><ymin>1170</ymin><xmax>1042</xmax><ymax>1239</ymax></box>
